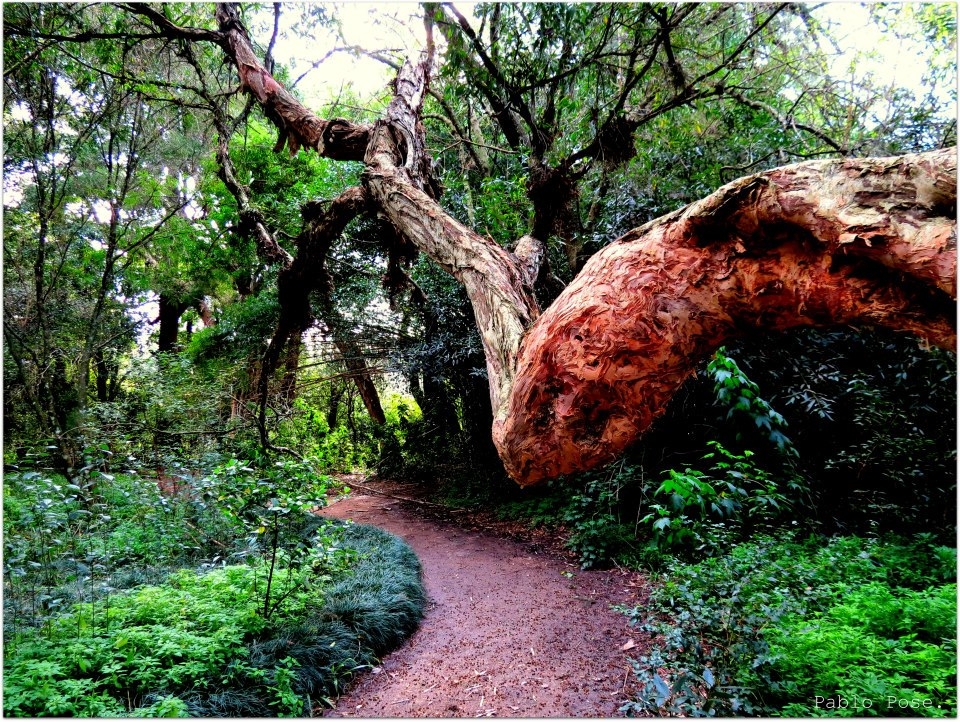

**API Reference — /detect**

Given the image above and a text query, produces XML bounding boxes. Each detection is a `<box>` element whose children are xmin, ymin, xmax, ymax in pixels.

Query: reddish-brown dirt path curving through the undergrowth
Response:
<box><xmin>322</xmin><ymin>477</ymin><xmax>648</xmax><ymax>718</ymax></box>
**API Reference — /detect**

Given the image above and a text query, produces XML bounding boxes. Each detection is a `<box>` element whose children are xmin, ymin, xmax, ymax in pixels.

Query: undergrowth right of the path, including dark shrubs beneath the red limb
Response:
<box><xmin>416</xmin><ymin>332</ymin><xmax>957</xmax><ymax>717</ymax></box>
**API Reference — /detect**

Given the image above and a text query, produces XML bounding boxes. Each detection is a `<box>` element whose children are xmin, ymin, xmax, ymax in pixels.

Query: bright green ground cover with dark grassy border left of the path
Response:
<box><xmin>4</xmin><ymin>523</ymin><xmax>425</xmax><ymax>717</ymax></box>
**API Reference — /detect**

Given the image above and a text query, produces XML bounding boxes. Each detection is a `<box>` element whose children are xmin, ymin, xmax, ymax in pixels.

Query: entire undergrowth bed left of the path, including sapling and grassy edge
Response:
<box><xmin>4</xmin><ymin>459</ymin><xmax>424</xmax><ymax>717</ymax></box>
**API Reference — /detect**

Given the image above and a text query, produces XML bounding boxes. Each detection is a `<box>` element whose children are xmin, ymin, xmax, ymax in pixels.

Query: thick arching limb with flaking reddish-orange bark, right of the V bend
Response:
<box><xmin>494</xmin><ymin>149</ymin><xmax>956</xmax><ymax>484</ymax></box>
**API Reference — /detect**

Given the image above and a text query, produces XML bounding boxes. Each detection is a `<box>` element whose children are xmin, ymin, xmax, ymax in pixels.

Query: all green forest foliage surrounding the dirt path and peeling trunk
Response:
<box><xmin>3</xmin><ymin>3</ymin><xmax>957</xmax><ymax>716</ymax></box>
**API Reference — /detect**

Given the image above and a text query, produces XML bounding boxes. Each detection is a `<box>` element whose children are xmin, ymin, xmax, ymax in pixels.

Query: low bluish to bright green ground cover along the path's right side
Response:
<box><xmin>623</xmin><ymin>537</ymin><xmax>956</xmax><ymax>716</ymax></box>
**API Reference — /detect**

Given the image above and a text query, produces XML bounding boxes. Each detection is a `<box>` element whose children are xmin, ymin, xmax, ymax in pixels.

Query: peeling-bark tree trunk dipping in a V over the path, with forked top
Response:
<box><xmin>210</xmin><ymin>5</ymin><xmax>956</xmax><ymax>485</ymax></box>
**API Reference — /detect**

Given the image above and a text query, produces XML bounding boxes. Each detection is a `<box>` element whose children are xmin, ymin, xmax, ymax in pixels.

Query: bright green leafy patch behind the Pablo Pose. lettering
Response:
<box><xmin>767</xmin><ymin>582</ymin><xmax>957</xmax><ymax>717</ymax></box>
